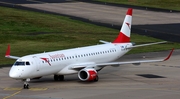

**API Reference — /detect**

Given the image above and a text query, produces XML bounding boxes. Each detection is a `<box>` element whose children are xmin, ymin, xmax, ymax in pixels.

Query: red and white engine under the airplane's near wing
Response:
<box><xmin>78</xmin><ymin>68</ymin><xmax>98</xmax><ymax>81</ymax></box>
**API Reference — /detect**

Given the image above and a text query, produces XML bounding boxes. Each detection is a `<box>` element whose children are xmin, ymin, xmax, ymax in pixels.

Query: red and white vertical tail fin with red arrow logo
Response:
<box><xmin>113</xmin><ymin>8</ymin><xmax>133</xmax><ymax>43</ymax></box>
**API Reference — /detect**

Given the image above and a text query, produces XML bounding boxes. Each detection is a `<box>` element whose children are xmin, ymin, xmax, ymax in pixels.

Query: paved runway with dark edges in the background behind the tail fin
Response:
<box><xmin>0</xmin><ymin>0</ymin><xmax>180</xmax><ymax>42</ymax></box>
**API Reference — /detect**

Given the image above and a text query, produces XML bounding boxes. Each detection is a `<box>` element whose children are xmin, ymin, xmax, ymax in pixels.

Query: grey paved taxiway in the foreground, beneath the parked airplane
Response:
<box><xmin>0</xmin><ymin>50</ymin><xmax>180</xmax><ymax>99</ymax></box>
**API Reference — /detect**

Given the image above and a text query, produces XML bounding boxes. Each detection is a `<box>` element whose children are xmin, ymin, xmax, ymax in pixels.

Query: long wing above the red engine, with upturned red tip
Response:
<box><xmin>71</xmin><ymin>49</ymin><xmax>174</xmax><ymax>69</ymax></box>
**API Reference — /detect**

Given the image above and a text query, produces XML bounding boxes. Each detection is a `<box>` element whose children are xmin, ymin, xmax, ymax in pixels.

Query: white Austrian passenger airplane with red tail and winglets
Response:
<box><xmin>5</xmin><ymin>8</ymin><xmax>173</xmax><ymax>89</ymax></box>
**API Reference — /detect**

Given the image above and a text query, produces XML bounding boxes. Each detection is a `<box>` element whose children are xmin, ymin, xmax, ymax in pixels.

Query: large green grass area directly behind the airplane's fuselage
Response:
<box><xmin>0</xmin><ymin>7</ymin><xmax>180</xmax><ymax>65</ymax></box>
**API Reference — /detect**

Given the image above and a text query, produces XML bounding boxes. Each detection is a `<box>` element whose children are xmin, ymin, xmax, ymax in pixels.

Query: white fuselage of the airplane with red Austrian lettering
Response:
<box><xmin>9</xmin><ymin>43</ymin><xmax>132</xmax><ymax>79</ymax></box>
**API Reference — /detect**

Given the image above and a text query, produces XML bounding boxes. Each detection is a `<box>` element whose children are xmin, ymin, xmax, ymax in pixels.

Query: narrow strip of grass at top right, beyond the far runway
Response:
<box><xmin>94</xmin><ymin>0</ymin><xmax>180</xmax><ymax>11</ymax></box>
